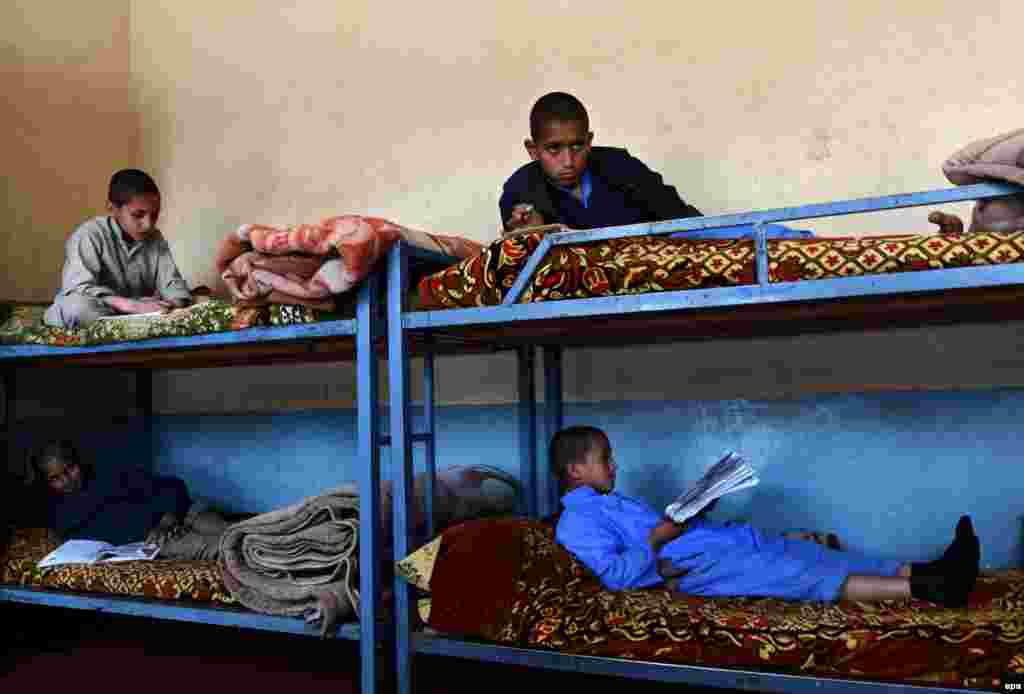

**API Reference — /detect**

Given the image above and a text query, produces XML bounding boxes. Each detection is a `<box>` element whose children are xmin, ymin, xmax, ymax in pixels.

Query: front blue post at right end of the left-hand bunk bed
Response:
<box><xmin>355</xmin><ymin>273</ymin><xmax>382</xmax><ymax>694</ymax></box>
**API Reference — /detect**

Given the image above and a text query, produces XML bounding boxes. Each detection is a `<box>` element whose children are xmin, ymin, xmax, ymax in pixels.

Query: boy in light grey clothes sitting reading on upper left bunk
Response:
<box><xmin>44</xmin><ymin>169</ymin><xmax>191</xmax><ymax>329</ymax></box>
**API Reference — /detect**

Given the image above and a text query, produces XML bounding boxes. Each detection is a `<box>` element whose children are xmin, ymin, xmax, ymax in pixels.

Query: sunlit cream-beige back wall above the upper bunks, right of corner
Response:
<box><xmin>125</xmin><ymin>0</ymin><xmax>1024</xmax><ymax>292</ymax></box>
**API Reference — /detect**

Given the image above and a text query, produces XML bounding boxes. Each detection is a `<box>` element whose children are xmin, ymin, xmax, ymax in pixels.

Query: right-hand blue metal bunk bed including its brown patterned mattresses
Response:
<box><xmin>387</xmin><ymin>183</ymin><xmax>1024</xmax><ymax>692</ymax></box>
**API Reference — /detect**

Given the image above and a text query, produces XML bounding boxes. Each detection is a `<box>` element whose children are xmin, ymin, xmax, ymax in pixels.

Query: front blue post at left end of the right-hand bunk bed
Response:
<box><xmin>387</xmin><ymin>243</ymin><xmax>413</xmax><ymax>694</ymax></box>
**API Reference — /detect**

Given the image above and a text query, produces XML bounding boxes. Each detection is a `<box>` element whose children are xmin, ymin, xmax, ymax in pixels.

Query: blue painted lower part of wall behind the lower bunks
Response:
<box><xmin>19</xmin><ymin>389</ymin><xmax>1024</xmax><ymax>566</ymax></box>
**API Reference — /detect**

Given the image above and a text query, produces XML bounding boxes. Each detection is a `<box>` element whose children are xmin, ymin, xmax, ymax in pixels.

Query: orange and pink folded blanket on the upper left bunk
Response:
<box><xmin>216</xmin><ymin>215</ymin><xmax>482</xmax><ymax>308</ymax></box>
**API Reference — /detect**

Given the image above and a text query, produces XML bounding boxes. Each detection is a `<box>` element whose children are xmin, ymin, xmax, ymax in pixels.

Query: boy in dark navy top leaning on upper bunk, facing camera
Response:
<box><xmin>499</xmin><ymin>92</ymin><xmax>700</xmax><ymax>232</ymax></box>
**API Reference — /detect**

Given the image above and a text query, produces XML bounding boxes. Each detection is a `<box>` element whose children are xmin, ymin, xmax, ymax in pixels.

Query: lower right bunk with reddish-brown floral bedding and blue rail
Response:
<box><xmin>397</xmin><ymin>519</ymin><xmax>1024</xmax><ymax>692</ymax></box>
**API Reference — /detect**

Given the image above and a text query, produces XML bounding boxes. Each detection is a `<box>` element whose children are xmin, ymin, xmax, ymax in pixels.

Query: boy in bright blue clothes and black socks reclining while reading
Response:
<box><xmin>550</xmin><ymin>427</ymin><xmax>981</xmax><ymax>607</ymax></box>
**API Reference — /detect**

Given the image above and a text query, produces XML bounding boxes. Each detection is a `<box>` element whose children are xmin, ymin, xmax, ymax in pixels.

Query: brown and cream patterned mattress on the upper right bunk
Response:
<box><xmin>416</xmin><ymin>230</ymin><xmax>1024</xmax><ymax>310</ymax></box>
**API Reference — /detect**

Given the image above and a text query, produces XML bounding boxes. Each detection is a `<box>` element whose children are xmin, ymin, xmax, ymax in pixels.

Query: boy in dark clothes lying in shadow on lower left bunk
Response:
<box><xmin>32</xmin><ymin>440</ymin><xmax>227</xmax><ymax>559</ymax></box>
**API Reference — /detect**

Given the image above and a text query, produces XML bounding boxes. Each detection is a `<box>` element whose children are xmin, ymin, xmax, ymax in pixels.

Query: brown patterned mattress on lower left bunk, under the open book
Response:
<box><xmin>0</xmin><ymin>528</ymin><xmax>238</xmax><ymax>605</ymax></box>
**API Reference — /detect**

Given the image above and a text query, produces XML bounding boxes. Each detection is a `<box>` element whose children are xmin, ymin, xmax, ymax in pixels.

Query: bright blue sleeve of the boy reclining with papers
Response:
<box><xmin>555</xmin><ymin>512</ymin><xmax>662</xmax><ymax>591</ymax></box>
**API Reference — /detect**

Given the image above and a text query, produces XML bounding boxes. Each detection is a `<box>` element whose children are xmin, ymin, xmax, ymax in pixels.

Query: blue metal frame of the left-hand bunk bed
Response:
<box><xmin>0</xmin><ymin>273</ymin><xmax>390</xmax><ymax>694</ymax></box>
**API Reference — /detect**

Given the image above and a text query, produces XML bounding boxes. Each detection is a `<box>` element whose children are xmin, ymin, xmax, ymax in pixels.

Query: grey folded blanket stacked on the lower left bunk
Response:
<box><xmin>218</xmin><ymin>485</ymin><xmax>359</xmax><ymax>636</ymax></box>
